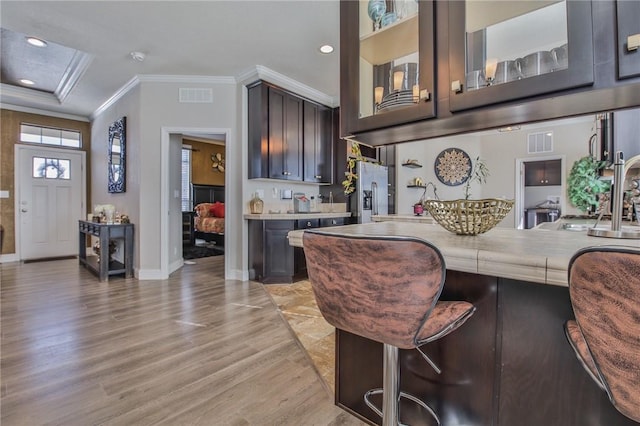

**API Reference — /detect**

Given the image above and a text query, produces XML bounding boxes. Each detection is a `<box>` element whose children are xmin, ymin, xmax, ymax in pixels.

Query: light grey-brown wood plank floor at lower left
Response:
<box><xmin>0</xmin><ymin>256</ymin><xmax>363</xmax><ymax>426</ymax></box>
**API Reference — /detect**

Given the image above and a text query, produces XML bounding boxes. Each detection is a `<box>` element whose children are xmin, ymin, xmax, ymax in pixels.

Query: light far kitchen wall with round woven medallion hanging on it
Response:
<box><xmin>396</xmin><ymin>116</ymin><xmax>595</xmax><ymax>227</ymax></box>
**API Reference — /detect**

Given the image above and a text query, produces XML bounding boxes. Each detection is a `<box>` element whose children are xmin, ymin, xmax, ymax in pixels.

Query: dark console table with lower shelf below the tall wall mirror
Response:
<box><xmin>78</xmin><ymin>220</ymin><xmax>133</xmax><ymax>281</ymax></box>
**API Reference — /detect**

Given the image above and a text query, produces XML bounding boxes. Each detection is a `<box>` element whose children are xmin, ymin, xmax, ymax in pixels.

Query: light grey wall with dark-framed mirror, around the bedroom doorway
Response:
<box><xmin>91</xmin><ymin>76</ymin><xmax>242</xmax><ymax>279</ymax></box>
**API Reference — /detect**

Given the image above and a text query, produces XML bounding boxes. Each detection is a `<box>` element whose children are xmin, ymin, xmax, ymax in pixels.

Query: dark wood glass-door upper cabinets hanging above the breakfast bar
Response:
<box><xmin>340</xmin><ymin>0</ymin><xmax>640</xmax><ymax>145</ymax></box>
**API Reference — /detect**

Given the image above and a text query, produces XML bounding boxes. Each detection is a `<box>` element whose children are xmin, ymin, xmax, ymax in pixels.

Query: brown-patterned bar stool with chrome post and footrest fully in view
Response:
<box><xmin>303</xmin><ymin>230</ymin><xmax>475</xmax><ymax>426</ymax></box>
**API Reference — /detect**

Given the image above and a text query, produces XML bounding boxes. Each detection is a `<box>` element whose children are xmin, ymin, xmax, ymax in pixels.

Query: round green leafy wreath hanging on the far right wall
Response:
<box><xmin>567</xmin><ymin>155</ymin><xmax>610</xmax><ymax>212</ymax></box>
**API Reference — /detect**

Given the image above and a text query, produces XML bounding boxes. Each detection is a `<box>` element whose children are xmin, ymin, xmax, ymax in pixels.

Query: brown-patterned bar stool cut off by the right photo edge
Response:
<box><xmin>565</xmin><ymin>246</ymin><xmax>640</xmax><ymax>422</ymax></box>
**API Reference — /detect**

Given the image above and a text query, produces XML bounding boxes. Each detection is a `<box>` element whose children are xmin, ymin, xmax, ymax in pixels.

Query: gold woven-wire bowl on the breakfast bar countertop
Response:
<box><xmin>424</xmin><ymin>198</ymin><xmax>514</xmax><ymax>235</ymax></box>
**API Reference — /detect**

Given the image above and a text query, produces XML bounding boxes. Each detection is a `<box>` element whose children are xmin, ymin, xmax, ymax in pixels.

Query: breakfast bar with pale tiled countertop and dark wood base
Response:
<box><xmin>288</xmin><ymin>221</ymin><xmax>640</xmax><ymax>426</ymax></box>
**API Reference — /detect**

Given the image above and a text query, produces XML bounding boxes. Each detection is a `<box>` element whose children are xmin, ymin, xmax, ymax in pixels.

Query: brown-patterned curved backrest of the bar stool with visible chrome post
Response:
<box><xmin>303</xmin><ymin>230</ymin><xmax>445</xmax><ymax>349</ymax></box>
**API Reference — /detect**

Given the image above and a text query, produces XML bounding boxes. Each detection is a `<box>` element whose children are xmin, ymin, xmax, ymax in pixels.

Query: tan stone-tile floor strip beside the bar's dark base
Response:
<box><xmin>264</xmin><ymin>280</ymin><xmax>335</xmax><ymax>394</ymax></box>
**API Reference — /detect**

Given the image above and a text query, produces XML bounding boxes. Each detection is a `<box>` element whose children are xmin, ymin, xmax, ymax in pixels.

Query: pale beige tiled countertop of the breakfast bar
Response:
<box><xmin>288</xmin><ymin>221</ymin><xmax>640</xmax><ymax>286</ymax></box>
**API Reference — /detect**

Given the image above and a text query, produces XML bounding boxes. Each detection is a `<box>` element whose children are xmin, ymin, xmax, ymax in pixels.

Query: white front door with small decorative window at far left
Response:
<box><xmin>16</xmin><ymin>145</ymin><xmax>86</xmax><ymax>260</ymax></box>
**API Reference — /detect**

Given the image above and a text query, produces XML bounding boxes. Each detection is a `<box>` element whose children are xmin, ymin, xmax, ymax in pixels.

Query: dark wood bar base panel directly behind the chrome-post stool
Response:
<box><xmin>336</xmin><ymin>270</ymin><xmax>497</xmax><ymax>426</ymax></box>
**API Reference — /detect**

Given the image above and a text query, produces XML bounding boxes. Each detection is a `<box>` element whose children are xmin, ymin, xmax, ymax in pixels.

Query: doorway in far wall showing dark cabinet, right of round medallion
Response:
<box><xmin>514</xmin><ymin>155</ymin><xmax>566</xmax><ymax>229</ymax></box>
